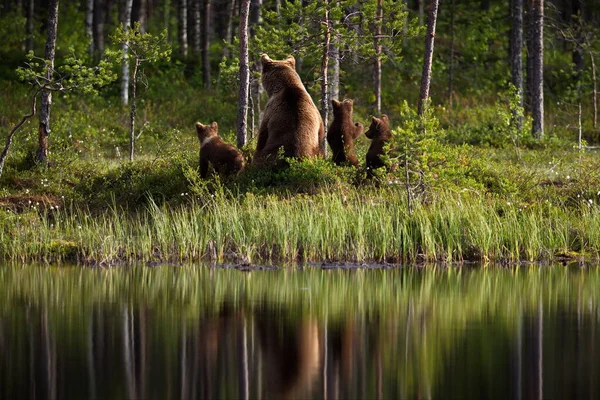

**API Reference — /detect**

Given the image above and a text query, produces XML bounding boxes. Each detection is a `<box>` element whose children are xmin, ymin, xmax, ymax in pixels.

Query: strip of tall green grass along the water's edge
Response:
<box><xmin>0</xmin><ymin>190</ymin><xmax>600</xmax><ymax>264</ymax></box>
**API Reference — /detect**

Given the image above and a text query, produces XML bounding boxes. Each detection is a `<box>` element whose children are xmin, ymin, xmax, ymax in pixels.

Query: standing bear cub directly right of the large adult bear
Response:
<box><xmin>327</xmin><ymin>99</ymin><xmax>363</xmax><ymax>168</ymax></box>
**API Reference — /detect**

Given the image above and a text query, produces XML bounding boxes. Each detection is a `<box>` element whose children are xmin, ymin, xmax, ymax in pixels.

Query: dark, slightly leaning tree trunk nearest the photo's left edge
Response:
<box><xmin>35</xmin><ymin>0</ymin><xmax>58</xmax><ymax>163</ymax></box>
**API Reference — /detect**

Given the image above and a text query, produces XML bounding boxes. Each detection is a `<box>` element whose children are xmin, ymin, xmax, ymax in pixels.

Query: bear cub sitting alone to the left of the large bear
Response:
<box><xmin>196</xmin><ymin>122</ymin><xmax>244</xmax><ymax>178</ymax></box>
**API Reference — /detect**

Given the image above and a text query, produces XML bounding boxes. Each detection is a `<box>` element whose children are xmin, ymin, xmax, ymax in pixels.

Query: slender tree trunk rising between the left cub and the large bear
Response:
<box><xmin>237</xmin><ymin>0</ymin><xmax>250</xmax><ymax>148</ymax></box>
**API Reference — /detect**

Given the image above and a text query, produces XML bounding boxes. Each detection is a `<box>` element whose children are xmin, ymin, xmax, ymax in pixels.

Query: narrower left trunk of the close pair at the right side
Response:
<box><xmin>510</xmin><ymin>0</ymin><xmax>523</xmax><ymax>131</ymax></box>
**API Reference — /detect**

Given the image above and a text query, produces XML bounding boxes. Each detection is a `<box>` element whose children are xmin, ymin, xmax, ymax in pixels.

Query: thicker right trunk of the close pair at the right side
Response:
<box><xmin>530</xmin><ymin>0</ymin><xmax>544</xmax><ymax>139</ymax></box>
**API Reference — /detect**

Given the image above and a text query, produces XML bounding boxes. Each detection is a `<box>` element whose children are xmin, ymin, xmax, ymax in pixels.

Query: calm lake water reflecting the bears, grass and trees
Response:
<box><xmin>0</xmin><ymin>266</ymin><xmax>600</xmax><ymax>399</ymax></box>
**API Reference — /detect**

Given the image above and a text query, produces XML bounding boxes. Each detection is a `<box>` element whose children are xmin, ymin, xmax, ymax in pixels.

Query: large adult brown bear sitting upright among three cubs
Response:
<box><xmin>254</xmin><ymin>54</ymin><xmax>325</xmax><ymax>165</ymax></box>
